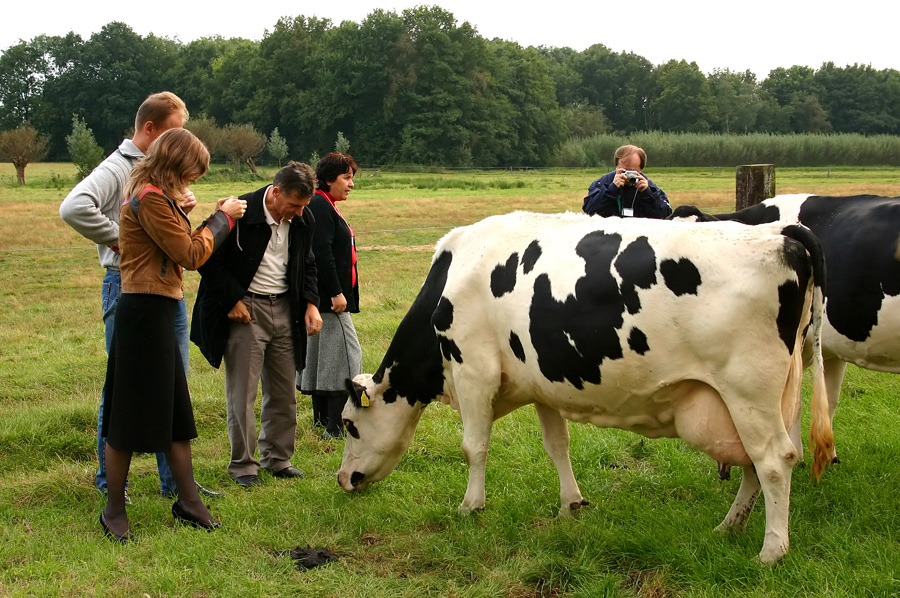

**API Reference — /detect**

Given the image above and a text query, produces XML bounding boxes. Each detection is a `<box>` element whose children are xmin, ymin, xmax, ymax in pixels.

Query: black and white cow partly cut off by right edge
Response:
<box><xmin>672</xmin><ymin>194</ymin><xmax>900</xmax><ymax>462</ymax></box>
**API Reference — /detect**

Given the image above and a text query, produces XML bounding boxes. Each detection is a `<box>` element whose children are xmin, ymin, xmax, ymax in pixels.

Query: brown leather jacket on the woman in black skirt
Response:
<box><xmin>119</xmin><ymin>185</ymin><xmax>234</xmax><ymax>299</ymax></box>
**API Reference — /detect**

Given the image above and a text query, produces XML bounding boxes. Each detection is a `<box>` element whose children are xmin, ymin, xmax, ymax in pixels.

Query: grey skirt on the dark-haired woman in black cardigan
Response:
<box><xmin>297</xmin><ymin>312</ymin><xmax>362</xmax><ymax>395</ymax></box>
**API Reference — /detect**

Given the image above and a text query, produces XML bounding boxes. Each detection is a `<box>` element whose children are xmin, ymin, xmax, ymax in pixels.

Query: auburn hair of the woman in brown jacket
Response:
<box><xmin>125</xmin><ymin>129</ymin><xmax>209</xmax><ymax>205</ymax></box>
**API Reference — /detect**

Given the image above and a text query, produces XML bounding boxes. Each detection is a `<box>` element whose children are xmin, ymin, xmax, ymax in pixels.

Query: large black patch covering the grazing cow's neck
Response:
<box><xmin>372</xmin><ymin>251</ymin><xmax>461</xmax><ymax>406</ymax></box>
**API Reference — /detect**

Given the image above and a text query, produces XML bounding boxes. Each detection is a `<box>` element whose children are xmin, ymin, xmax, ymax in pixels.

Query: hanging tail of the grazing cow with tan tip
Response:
<box><xmin>782</xmin><ymin>225</ymin><xmax>834</xmax><ymax>480</ymax></box>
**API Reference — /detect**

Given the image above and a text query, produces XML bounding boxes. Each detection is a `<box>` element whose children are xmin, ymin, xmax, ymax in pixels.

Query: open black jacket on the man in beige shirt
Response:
<box><xmin>191</xmin><ymin>185</ymin><xmax>319</xmax><ymax>371</ymax></box>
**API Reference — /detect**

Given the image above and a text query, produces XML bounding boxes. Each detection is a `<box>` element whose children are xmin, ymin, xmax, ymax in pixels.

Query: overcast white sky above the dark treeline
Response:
<box><xmin>0</xmin><ymin>0</ymin><xmax>900</xmax><ymax>80</ymax></box>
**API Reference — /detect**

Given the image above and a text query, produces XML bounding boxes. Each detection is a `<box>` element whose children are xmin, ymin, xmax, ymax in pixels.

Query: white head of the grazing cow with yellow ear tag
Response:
<box><xmin>338</xmin><ymin>372</ymin><xmax>425</xmax><ymax>491</ymax></box>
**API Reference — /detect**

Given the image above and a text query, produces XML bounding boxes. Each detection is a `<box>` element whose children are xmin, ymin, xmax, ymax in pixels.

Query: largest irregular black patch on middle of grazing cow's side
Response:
<box><xmin>529</xmin><ymin>231</ymin><xmax>625</xmax><ymax>389</ymax></box>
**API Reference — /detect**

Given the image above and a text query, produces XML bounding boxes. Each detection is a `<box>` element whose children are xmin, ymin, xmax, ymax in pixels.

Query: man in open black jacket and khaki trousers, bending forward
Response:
<box><xmin>191</xmin><ymin>162</ymin><xmax>322</xmax><ymax>488</ymax></box>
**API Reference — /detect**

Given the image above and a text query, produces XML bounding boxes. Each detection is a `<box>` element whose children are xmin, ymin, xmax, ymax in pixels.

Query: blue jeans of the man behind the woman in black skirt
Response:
<box><xmin>97</xmin><ymin>268</ymin><xmax>189</xmax><ymax>494</ymax></box>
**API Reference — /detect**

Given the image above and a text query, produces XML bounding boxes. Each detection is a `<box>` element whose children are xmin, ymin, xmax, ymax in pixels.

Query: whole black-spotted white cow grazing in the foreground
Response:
<box><xmin>338</xmin><ymin>212</ymin><xmax>831</xmax><ymax>562</ymax></box>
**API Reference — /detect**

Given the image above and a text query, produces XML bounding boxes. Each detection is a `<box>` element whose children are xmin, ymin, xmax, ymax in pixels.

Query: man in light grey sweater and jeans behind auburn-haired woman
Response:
<box><xmin>59</xmin><ymin>91</ymin><xmax>220</xmax><ymax>496</ymax></box>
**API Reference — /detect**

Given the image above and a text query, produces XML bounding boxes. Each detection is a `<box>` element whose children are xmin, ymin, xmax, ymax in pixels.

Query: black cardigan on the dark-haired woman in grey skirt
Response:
<box><xmin>307</xmin><ymin>193</ymin><xmax>359</xmax><ymax>314</ymax></box>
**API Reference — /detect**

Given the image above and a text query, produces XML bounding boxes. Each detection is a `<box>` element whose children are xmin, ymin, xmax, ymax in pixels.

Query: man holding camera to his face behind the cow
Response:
<box><xmin>582</xmin><ymin>145</ymin><xmax>672</xmax><ymax>218</ymax></box>
